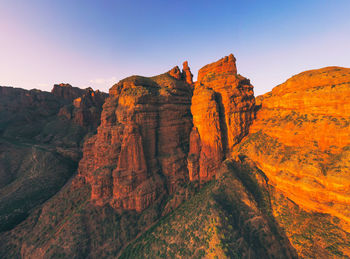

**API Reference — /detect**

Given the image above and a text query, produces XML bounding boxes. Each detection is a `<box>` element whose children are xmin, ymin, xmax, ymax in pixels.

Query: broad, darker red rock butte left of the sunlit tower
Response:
<box><xmin>79</xmin><ymin>63</ymin><xmax>192</xmax><ymax>211</ymax></box>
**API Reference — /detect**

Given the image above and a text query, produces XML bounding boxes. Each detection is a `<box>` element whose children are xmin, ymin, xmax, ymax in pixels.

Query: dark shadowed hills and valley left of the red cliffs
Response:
<box><xmin>0</xmin><ymin>85</ymin><xmax>105</xmax><ymax>231</ymax></box>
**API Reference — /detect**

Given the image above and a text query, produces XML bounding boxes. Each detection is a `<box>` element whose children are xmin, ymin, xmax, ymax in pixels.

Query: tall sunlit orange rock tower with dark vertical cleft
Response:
<box><xmin>188</xmin><ymin>54</ymin><xmax>255</xmax><ymax>182</ymax></box>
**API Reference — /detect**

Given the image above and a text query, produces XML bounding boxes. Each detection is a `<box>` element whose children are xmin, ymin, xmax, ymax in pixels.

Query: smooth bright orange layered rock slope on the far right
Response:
<box><xmin>237</xmin><ymin>67</ymin><xmax>350</xmax><ymax>230</ymax></box>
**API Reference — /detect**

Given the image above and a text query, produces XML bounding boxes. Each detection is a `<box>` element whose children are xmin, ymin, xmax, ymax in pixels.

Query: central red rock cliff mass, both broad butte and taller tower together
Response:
<box><xmin>79</xmin><ymin>55</ymin><xmax>254</xmax><ymax>211</ymax></box>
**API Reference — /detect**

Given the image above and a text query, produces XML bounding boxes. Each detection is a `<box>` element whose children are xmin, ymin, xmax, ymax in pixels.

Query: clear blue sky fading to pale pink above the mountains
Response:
<box><xmin>0</xmin><ymin>0</ymin><xmax>350</xmax><ymax>95</ymax></box>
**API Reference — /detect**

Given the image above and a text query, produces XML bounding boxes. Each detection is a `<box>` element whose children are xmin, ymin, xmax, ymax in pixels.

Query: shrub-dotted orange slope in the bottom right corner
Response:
<box><xmin>271</xmin><ymin>192</ymin><xmax>350</xmax><ymax>258</ymax></box>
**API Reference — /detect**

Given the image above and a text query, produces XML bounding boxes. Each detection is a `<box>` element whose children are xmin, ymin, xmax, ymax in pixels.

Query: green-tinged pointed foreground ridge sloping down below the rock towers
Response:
<box><xmin>120</xmin><ymin>160</ymin><xmax>297</xmax><ymax>258</ymax></box>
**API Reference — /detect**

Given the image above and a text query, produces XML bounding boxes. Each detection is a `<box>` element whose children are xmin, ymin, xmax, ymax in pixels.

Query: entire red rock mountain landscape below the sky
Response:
<box><xmin>0</xmin><ymin>54</ymin><xmax>350</xmax><ymax>258</ymax></box>
